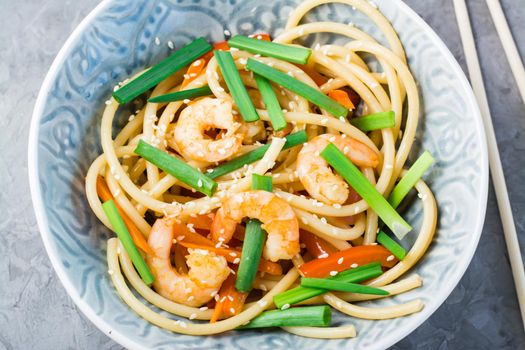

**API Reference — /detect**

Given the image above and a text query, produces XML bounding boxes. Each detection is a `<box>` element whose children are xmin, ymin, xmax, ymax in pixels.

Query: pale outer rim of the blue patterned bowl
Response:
<box><xmin>28</xmin><ymin>0</ymin><xmax>489</xmax><ymax>349</ymax></box>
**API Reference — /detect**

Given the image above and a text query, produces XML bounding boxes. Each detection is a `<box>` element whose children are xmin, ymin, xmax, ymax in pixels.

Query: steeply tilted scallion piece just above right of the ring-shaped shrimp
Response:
<box><xmin>214</xmin><ymin>51</ymin><xmax>259</xmax><ymax>122</ymax></box>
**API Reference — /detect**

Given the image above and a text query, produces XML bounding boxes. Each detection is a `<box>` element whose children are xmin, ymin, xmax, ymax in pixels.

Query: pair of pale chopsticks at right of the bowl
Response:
<box><xmin>454</xmin><ymin>0</ymin><xmax>525</xmax><ymax>325</ymax></box>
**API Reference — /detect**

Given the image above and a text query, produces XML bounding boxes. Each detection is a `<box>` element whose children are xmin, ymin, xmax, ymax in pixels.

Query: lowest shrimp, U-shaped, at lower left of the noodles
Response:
<box><xmin>146</xmin><ymin>219</ymin><xmax>230</xmax><ymax>307</ymax></box>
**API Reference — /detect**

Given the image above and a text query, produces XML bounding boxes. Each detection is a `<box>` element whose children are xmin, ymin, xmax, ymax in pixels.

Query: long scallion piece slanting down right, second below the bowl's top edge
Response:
<box><xmin>246</xmin><ymin>58</ymin><xmax>348</xmax><ymax>118</ymax></box>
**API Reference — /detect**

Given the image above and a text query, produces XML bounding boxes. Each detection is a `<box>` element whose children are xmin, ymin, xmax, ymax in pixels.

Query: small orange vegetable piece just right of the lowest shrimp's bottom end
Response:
<box><xmin>210</xmin><ymin>274</ymin><xmax>248</xmax><ymax>323</ymax></box>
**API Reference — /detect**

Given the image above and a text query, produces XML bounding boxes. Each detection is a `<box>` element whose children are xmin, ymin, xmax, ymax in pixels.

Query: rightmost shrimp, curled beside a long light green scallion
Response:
<box><xmin>297</xmin><ymin>134</ymin><xmax>379</xmax><ymax>205</ymax></box>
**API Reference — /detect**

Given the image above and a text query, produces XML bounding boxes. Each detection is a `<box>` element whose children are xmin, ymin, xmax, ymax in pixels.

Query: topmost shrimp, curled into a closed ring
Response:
<box><xmin>173</xmin><ymin>97</ymin><xmax>243</xmax><ymax>163</ymax></box>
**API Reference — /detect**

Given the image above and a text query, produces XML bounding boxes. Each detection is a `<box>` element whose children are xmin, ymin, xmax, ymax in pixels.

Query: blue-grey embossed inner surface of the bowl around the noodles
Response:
<box><xmin>29</xmin><ymin>0</ymin><xmax>488</xmax><ymax>350</ymax></box>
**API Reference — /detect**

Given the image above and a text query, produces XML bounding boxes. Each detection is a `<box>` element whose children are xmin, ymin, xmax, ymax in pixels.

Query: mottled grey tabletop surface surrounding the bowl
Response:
<box><xmin>0</xmin><ymin>0</ymin><xmax>525</xmax><ymax>350</ymax></box>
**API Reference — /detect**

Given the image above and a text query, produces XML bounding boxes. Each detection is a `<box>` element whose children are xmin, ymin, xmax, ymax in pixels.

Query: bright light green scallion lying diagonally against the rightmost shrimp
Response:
<box><xmin>321</xmin><ymin>143</ymin><xmax>412</xmax><ymax>239</ymax></box>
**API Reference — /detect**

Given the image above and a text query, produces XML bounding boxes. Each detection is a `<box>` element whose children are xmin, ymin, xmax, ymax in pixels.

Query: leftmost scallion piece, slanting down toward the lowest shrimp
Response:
<box><xmin>102</xmin><ymin>199</ymin><xmax>154</xmax><ymax>285</ymax></box>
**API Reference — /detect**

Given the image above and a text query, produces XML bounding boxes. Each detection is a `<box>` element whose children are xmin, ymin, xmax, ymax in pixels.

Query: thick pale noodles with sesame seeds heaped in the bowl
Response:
<box><xmin>86</xmin><ymin>0</ymin><xmax>437</xmax><ymax>338</ymax></box>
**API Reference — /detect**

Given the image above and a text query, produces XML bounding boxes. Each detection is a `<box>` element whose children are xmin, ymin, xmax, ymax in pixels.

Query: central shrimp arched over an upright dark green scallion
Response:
<box><xmin>211</xmin><ymin>191</ymin><xmax>299</xmax><ymax>261</ymax></box>
